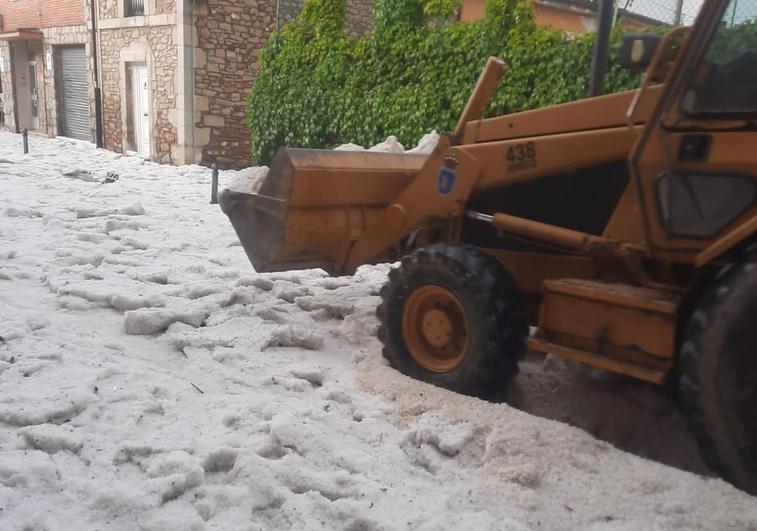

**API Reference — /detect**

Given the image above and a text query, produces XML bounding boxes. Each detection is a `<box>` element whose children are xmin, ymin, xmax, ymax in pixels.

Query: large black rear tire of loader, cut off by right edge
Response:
<box><xmin>678</xmin><ymin>250</ymin><xmax>757</xmax><ymax>494</ymax></box>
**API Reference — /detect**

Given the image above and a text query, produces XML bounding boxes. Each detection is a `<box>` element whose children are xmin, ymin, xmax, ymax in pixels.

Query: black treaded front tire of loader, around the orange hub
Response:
<box><xmin>376</xmin><ymin>244</ymin><xmax>528</xmax><ymax>399</ymax></box>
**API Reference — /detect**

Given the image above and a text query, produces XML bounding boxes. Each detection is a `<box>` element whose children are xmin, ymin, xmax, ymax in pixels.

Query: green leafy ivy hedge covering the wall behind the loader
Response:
<box><xmin>247</xmin><ymin>0</ymin><xmax>638</xmax><ymax>164</ymax></box>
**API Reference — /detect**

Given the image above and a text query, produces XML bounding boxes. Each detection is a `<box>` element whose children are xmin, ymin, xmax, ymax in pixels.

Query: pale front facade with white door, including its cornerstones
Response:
<box><xmin>97</xmin><ymin>0</ymin><xmax>188</xmax><ymax>164</ymax></box>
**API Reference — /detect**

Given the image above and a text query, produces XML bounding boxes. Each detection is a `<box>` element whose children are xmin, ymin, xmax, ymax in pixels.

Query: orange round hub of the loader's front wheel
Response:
<box><xmin>402</xmin><ymin>285</ymin><xmax>468</xmax><ymax>372</ymax></box>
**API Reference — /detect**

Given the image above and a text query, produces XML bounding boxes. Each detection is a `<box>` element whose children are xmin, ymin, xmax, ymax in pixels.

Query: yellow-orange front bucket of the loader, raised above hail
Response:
<box><xmin>219</xmin><ymin>148</ymin><xmax>428</xmax><ymax>274</ymax></box>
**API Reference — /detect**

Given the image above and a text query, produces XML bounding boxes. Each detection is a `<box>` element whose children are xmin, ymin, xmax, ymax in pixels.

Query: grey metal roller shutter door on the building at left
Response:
<box><xmin>60</xmin><ymin>46</ymin><xmax>91</xmax><ymax>140</ymax></box>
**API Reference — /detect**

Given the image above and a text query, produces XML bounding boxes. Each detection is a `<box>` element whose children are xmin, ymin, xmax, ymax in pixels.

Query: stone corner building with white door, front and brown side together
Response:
<box><xmin>98</xmin><ymin>0</ymin><xmax>276</xmax><ymax>168</ymax></box>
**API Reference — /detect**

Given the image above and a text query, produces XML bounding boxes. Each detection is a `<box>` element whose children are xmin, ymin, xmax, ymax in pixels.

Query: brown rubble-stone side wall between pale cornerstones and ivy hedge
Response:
<box><xmin>194</xmin><ymin>0</ymin><xmax>276</xmax><ymax>168</ymax></box>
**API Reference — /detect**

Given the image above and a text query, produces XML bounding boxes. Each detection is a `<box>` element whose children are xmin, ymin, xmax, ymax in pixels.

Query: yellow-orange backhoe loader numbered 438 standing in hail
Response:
<box><xmin>220</xmin><ymin>0</ymin><xmax>757</xmax><ymax>493</ymax></box>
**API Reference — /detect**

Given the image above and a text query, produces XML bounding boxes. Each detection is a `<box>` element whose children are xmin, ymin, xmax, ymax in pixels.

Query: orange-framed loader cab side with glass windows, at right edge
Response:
<box><xmin>630</xmin><ymin>0</ymin><xmax>757</xmax><ymax>262</ymax></box>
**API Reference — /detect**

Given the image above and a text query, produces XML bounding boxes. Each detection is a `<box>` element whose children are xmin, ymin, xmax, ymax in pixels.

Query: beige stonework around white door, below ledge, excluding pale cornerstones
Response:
<box><xmin>100</xmin><ymin>25</ymin><xmax>178</xmax><ymax>163</ymax></box>
